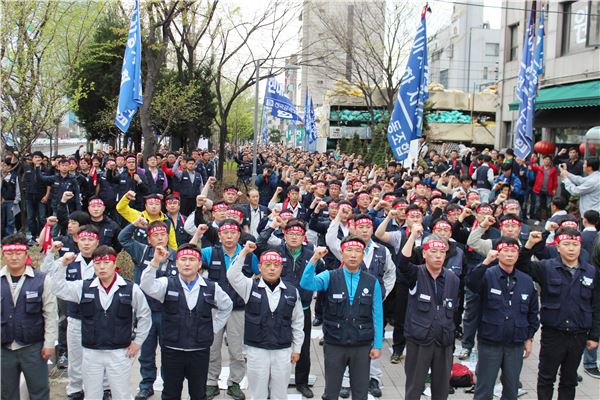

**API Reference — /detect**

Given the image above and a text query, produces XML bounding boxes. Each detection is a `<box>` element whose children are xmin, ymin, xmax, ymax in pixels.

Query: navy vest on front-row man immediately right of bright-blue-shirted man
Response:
<box><xmin>404</xmin><ymin>265</ymin><xmax>460</xmax><ymax>346</ymax></box>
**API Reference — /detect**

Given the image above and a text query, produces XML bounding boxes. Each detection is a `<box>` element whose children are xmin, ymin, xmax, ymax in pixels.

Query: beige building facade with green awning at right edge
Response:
<box><xmin>496</xmin><ymin>0</ymin><xmax>600</xmax><ymax>148</ymax></box>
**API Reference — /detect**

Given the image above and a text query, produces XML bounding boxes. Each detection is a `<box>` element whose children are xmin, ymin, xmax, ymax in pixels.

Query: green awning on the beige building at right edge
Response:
<box><xmin>508</xmin><ymin>80</ymin><xmax>600</xmax><ymax>111</ymax></box>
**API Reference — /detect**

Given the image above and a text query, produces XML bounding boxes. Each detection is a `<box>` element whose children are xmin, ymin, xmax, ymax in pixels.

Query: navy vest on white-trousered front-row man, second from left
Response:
<box><xmin>80</xmin><ymin>279</ymin><xmax>133</xmax><ymax>350</ymax></box>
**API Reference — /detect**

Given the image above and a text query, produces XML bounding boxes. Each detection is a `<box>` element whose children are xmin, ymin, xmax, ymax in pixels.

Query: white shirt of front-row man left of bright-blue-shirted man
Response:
<box><xmin>227</xmin><ymin>256</ymin><xmax>304</xmax><ymax>353</ymax></box>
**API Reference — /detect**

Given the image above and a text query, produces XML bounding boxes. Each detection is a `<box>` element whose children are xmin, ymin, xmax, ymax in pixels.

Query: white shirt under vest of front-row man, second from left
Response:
<box><xmin>48</xmin><ymin>257</ymin><xmax>152</xmax><ymax>346</ymax></box>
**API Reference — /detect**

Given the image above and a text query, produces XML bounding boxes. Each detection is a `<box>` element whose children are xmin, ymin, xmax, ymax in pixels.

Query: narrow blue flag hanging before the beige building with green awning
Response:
<box><xmin>514</xmin><ymin>2</ymin><xmax>543</xmax><ymax>159</ymax></box>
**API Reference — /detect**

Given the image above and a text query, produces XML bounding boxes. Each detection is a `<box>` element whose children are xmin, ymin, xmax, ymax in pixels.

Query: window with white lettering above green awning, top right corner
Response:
<box><xmin>560</xmin><ymin>1</ymin><xmax>598</xmax><ymax>55</ymax></box>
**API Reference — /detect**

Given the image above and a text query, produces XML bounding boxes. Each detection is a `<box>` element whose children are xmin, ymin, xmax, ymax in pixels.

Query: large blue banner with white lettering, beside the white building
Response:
<box><xmin>387</xmin><ymin>6</ymin><xmax>429</xmax><ymax>161</ymax></box>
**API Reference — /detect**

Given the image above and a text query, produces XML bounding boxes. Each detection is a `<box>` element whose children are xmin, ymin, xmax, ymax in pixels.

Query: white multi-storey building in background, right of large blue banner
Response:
<box><xmin>428</xmin><ymin>4</ymin><xmax>500</xmax><ymax>92</ymax></box>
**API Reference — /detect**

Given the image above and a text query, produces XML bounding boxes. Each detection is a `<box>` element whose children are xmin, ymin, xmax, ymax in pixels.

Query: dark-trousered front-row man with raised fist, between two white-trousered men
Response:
<box><xmin>141</xmin><ymin>244</ymin><xmax>233</xmax><ymax>400</ymax></box>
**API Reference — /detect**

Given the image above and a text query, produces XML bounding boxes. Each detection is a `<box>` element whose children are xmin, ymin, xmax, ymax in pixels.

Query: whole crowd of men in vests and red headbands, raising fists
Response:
<box><xmin>0</xmin><ymin>142</ymin><xmax>600</xmax><ymax>400</ymax></box>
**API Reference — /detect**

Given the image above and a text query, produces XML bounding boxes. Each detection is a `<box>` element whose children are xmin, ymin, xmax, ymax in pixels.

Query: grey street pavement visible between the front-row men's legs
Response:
<box><xmin>50</xmin><ymin>327</ymin><xmax>600</xmax><ymax>400</ymax></box>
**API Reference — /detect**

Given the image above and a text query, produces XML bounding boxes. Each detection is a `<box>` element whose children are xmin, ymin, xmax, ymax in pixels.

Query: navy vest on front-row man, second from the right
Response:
<box><xmin>477</xmin><ymin>265</ymin><xmax>537</xmax><ymax>344</ymax></box>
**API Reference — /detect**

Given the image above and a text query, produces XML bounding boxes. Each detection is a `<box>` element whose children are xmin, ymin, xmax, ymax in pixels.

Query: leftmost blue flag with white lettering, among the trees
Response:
<box><xmin>115</xmin><ymin>0</ymin><xmax>144</xmax><ymax>132</ymax></box>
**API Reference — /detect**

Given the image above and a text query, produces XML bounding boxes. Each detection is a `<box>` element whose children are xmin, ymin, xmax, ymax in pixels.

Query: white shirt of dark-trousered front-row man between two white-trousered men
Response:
<box><xmin>140</xmin><ymin>266</ymin><xmax>233</xmax><ymax>332</ymax></box>
